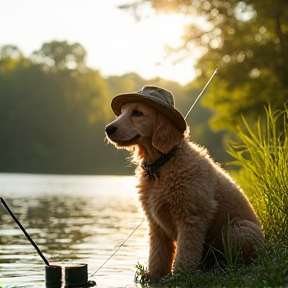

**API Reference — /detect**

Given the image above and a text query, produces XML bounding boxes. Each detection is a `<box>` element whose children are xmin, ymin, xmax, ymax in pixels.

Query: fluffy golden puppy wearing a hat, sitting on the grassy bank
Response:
<box><xmin>105</xmin><ymin>86</ymin><xmax>264</xmax><ymax>279</ymax></box>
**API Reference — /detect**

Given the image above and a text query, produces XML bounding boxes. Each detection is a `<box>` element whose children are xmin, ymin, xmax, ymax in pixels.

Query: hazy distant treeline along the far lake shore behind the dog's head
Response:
<box><xmin>0</xmin><ymin>41</ymin><xmax>226</xmax><ymax>174</ymax></box>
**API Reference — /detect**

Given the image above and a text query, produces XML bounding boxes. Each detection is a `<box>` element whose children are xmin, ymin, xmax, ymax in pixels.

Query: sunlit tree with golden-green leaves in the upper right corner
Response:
<box><xmin>127</xmin><ymin>0</ymin><xmax>288</xmax><ymax>131</ymax></box>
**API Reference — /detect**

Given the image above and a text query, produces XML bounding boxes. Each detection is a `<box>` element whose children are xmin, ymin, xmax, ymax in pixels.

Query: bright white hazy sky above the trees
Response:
<box><xmin>0</xmin><ymin>0</ymin><xmax>195</xmax><ymax>84</ymax></box>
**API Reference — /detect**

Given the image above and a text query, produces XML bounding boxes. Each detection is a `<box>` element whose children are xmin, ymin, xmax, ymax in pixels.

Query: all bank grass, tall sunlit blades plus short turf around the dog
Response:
<box><xmin>136</xmin><ymin>106</ymin><xmax>288</xmax><ymax>288</ymax></box>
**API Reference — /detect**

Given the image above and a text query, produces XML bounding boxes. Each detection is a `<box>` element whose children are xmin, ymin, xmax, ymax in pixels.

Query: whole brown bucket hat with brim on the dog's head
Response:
<box><xmin>111</xmin><ymin>85</ymin><xmax>186</xmax><ymax>133</ymax></box>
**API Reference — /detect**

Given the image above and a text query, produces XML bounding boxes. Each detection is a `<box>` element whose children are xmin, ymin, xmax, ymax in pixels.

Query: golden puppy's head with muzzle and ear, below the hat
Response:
<box><xmin>105</xmin><ymin>102</ymin><xmax>184</xmax><ymax>154</ymax></box>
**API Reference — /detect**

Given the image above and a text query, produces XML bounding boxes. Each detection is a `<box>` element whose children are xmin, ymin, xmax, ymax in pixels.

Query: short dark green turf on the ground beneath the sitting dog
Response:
<box><xmin>138</xmin><ymin>243</ymin><xmax>288</xmax><ymax>288</ymax></box>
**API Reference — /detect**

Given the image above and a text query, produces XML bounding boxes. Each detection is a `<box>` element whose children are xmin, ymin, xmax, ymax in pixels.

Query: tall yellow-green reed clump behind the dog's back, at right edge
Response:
<box><xmin>227</xmin><ymin>106</ymin><xmax>288</xmax><ymax>239</ymax></box>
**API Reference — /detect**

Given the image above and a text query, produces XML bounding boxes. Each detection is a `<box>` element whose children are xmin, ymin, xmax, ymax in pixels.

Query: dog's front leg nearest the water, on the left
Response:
<box><xmin>146</xmin><ymin>221</ymin><xmax>176</xmax><ymax>279</ymax></box>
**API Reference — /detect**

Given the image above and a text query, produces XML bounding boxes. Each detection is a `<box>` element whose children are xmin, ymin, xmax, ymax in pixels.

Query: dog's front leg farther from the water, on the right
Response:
<box><xmin>174</xmin><ymin>217</ymin><xmax>206</xmax><ymax>272</ymax></box>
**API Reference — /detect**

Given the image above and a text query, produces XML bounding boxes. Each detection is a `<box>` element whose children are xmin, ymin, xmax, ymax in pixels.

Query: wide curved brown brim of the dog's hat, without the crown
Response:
<box><xmin>111</xmin><ymin>93</ymin><xmax>186</xmax><ymax>133</ymax></box>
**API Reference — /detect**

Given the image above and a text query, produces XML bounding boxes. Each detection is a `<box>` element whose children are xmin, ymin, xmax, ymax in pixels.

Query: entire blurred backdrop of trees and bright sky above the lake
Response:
<box><xmin>0</xmin><ymin>0</ymin><xmax>288</xmax><ymax>175</ymax></box>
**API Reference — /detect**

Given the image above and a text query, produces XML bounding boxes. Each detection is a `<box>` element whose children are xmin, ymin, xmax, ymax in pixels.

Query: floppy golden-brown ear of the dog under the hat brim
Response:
<box><xmin>152</xmin><ymin>113</ymin><xmax>184</xmax><ymax>154</ymax></box>
